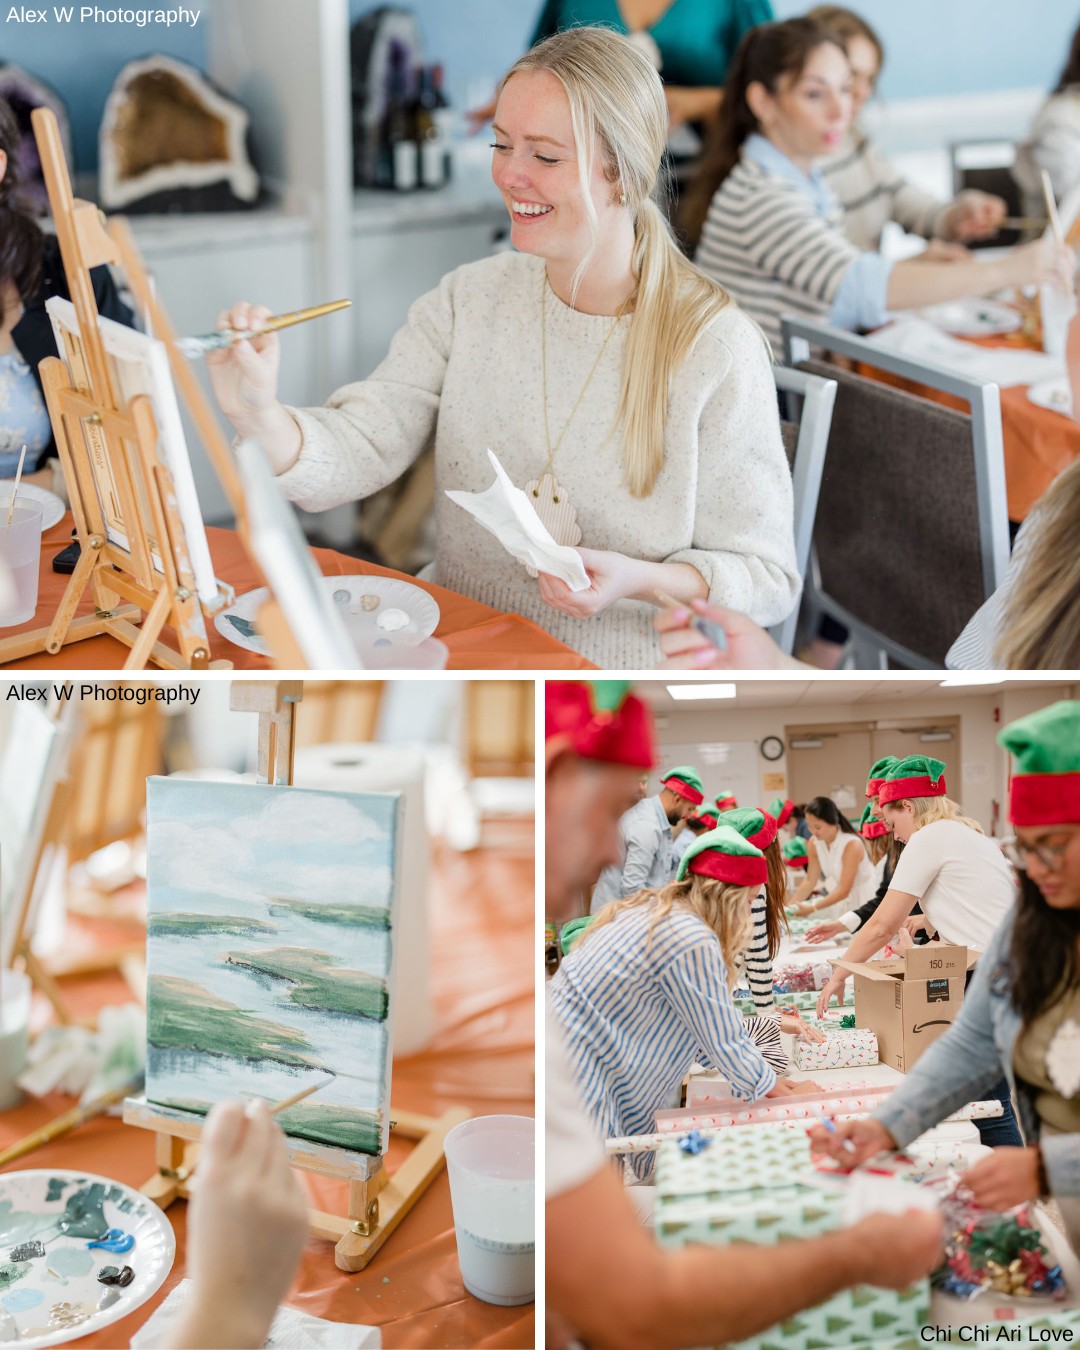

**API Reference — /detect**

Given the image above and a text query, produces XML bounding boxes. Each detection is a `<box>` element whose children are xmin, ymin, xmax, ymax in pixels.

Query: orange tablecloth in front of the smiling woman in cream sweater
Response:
<box><xmin>0</xmin><ymin>514</ymin><xmax>591</xmax><ymax>670</ymax></box>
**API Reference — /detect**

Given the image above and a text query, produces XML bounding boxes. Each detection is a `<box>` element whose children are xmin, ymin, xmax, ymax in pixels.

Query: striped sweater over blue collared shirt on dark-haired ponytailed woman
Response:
<box><xmin>694</xmin><ymin>155</ymin><xmax>860</xmax><ymax>359</ymax></box>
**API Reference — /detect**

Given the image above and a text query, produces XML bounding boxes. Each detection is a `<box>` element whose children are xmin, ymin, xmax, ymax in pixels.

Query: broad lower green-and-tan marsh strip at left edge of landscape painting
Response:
<box><xmin>147</xmin><ymin>975</ymin><xmax>319</xmax><ymax>1068</ymax></box>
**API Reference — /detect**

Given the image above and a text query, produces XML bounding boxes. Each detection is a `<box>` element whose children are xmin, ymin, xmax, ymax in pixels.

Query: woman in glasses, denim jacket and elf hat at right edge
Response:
<box><xmin>810</xmin><ymin>701</ymin><xmax>1080</xmax><ymax>1256</ymax></box>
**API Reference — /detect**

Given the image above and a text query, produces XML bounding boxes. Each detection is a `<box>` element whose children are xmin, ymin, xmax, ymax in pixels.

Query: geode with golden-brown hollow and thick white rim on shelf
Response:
<box><xmin>99</xmin><ymin>55</ymin><xmax>259</xmax><ymax>212</ymax></box>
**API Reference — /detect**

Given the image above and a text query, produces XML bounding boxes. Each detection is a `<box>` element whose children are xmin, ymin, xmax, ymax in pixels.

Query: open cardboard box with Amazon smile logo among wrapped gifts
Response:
<box><xmin>833</xmin><ymin>942</ymin><xmax>979</xmax><ymax>1073</ymax></box>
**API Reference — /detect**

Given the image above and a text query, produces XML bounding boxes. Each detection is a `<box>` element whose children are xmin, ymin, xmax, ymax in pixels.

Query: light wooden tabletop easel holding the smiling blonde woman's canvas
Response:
<box><xmin>0</xmin><ymin>108</ymin><xmax>242</xmax><ymax>670</ymax></box>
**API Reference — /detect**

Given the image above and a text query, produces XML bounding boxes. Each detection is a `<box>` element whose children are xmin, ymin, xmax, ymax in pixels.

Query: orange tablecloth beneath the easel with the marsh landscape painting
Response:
<box><xmin>0</xmin><ymin>837</ymin><xmax>535</xmax><ymax>1350</ymax></box>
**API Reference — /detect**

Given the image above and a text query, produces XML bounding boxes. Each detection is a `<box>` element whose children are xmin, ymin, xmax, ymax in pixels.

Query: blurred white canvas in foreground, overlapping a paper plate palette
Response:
<box><xmin>236</xmin><ymin>440</ymin><xmax>365</xmax><ymax>671</ymax></box>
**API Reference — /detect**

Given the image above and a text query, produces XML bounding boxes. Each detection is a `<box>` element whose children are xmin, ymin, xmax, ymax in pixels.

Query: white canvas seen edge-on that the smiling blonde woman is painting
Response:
<box><xmin>45</xmin><ymin>296</ymin><xmax>220</xmax><ymax>605</ymax></box>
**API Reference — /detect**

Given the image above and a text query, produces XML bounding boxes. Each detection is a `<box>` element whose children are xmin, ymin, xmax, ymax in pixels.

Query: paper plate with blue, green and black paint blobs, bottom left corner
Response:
<box><xmin>0</xmin><ymin>1168</ymin><xmax>176</xmax><ymax>1350</ymax></box>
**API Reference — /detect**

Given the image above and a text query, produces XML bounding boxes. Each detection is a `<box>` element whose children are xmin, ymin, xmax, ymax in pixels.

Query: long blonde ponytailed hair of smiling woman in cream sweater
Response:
<box><xmin>500</xmin><ymin>27</ymin><xmax>739</xmax><ymax>497</ymax></box>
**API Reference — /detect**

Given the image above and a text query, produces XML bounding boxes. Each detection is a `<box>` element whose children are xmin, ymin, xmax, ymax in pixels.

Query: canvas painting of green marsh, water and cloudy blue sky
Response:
<box><xmin>146</xmin><ymin>778</ymin><xmax>400</xmax><ymax>1153</ymax></box>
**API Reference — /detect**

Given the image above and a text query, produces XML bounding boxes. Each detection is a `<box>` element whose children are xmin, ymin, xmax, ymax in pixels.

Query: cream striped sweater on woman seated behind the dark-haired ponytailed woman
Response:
<box><xmin>818</xmin><ymin>131</ymin><xmax>949</xmax><ymax>252</ymax></box>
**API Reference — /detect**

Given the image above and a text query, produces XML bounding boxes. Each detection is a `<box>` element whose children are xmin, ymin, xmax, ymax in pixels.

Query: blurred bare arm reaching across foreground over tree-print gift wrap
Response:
<box><xmin>545</xmin><ymin>1168</ymin><xmax>941</xmax><ymax>1350</ymax></box>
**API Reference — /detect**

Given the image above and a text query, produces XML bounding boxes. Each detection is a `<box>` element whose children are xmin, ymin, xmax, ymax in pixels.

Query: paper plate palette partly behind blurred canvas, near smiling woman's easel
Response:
<box><xmin>213</xmin><ymin>576</ymin><xmax>439</xmax><ymax>662</ymax></box>
